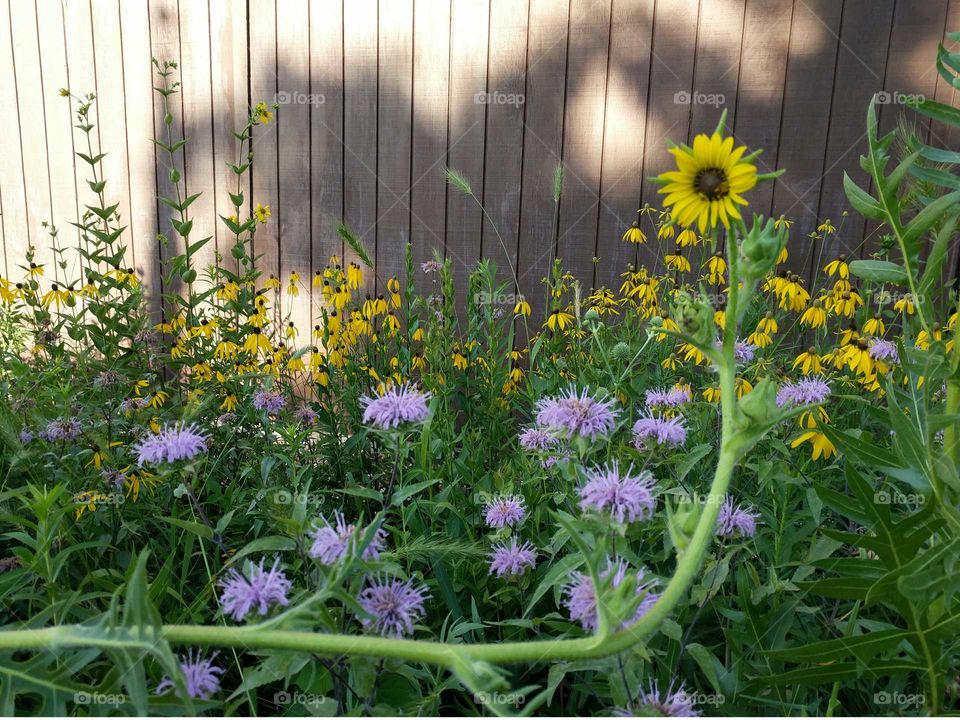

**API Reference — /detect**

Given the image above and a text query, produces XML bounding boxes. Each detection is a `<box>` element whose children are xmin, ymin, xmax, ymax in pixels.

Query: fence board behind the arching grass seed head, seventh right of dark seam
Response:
<box><xmin>446</xmin><ymin>0</ymin><xmax>490</xmax><ymax>307</ymax></box>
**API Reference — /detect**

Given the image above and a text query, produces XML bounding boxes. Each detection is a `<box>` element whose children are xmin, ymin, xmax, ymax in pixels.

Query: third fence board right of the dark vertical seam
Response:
<box><xmin>310</xmin><ymin>0</ymin><xmax>344</xmax><ymax>324</ymax></box>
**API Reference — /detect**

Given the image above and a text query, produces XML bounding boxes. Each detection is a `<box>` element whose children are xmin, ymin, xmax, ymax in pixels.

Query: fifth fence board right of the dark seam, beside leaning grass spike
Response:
<box><xmin>374</xmin><ymin>0</ymin><xmax>413</xmax><ymax>295</ymax></box>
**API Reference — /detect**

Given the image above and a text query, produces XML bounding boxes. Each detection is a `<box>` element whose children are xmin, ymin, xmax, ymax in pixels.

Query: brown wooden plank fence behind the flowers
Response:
<box><xmin>0</xmin><ymin>0</ymin><xmax>960</xmax><ymax>319</ymax></box>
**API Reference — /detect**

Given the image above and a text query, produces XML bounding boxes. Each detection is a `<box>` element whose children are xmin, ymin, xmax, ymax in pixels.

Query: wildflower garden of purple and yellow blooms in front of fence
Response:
<box><xmin>0</xmin><ymin>26</ymin><xmax>960</xmax><ymax>716</ymax></box>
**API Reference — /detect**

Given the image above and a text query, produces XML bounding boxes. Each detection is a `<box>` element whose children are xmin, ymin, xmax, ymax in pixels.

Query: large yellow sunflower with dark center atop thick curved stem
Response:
<box><xmin>659</xmin><ymin>132</ymin><xmax>757</xmax><ymax>233</ymax></box>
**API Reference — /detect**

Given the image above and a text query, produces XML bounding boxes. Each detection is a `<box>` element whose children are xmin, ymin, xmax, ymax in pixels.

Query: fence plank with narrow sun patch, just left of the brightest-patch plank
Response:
<box><xmin>557</xmin><ymin>0</ymin><xmax>610</xmax><ymax>290</ymax></box>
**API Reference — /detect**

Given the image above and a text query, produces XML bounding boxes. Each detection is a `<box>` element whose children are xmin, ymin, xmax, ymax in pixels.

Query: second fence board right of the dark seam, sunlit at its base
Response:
<box><xmin>277</xmin><ymin>0</ymin><xmax>311</xmax><ymax>347</ymax></box>
